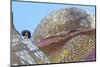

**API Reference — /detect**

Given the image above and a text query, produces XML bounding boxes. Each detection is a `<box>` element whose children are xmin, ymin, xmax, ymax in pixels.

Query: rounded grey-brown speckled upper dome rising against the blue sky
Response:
<box><xmin>33</xmin><ymin>7</ymin><xmax>95</xmax><ymax>43</ymax></box>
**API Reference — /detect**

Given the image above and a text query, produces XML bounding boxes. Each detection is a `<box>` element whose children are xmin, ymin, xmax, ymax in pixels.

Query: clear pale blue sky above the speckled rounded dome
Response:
<box><xmin>12</xmin><ymin>1</ymin><xmax>95</xmax><ymax>32</ymax></box>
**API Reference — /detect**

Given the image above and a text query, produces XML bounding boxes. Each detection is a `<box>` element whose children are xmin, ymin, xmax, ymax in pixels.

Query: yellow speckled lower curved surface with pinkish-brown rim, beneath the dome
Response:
<box><xmin>38</xmin><ymin>29</ymin><xmax>96</xmax><ymax>63</ymax></box>
